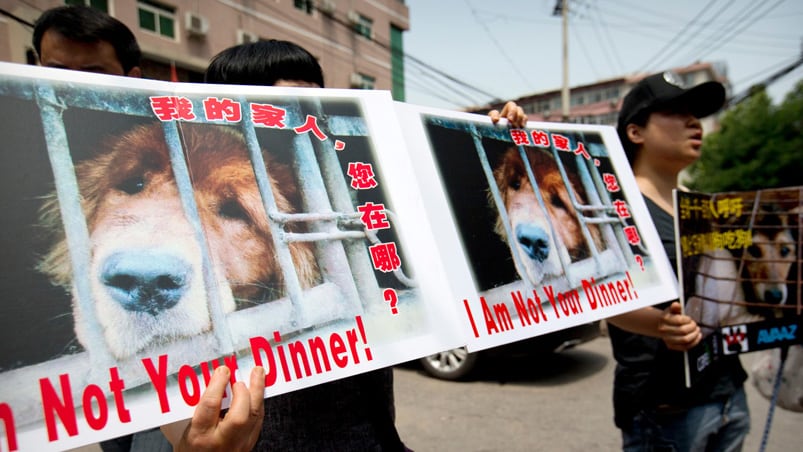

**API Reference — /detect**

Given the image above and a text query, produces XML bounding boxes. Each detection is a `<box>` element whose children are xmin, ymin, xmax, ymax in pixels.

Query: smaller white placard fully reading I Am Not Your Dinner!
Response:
<box><xmin>392</xmin><ymin>104</ymin><xmax>676</xmax><ymax>350</ymax></box>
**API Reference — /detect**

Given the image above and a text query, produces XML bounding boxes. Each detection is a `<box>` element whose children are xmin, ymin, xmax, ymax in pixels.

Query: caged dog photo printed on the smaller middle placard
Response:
<box><xmin>425</xmin><ymin>117</ymin><xmax>649</xmax><ymax>291</ymax></box>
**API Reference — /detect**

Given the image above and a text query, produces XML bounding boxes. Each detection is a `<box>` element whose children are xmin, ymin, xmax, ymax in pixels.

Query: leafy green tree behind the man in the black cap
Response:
<box><xmin>687</xmin><ymin>80</ymin><xmax>803</xmax><ymax>192</ymax></box>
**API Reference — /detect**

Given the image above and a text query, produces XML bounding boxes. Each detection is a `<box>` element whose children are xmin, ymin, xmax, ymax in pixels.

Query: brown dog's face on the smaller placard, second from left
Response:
<box><xmin>494</xmin><ymin>148</ymin><xmax>601</xmax><ymax>284</ymax></box>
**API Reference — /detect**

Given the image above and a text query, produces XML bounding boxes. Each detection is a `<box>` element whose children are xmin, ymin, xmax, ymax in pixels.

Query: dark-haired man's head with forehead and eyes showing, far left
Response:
<box><xmin>32</xmin><ymin>6</ymin><xmax>142</xmax><ymax>77</ymax></box>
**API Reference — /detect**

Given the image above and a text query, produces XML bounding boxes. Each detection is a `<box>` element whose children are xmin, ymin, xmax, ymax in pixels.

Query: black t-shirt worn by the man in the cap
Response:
<box><xmin>608</xmin><ymin>197</ymin><xmax>747</xmax><ymax>429</ymax></box>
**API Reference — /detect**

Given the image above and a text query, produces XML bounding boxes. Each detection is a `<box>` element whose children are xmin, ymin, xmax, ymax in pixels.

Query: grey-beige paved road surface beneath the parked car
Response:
<box><xmin>395</xmin><ymin>337</ymin><xmax>803</xmax><ymax>452</ymax></box>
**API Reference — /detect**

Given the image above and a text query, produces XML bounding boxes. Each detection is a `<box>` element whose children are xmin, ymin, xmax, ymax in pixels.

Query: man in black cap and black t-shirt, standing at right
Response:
<box><xmin>608</xmin><ymin>72</ymin><xmax>750</xmax><ymax>451</ymax></box>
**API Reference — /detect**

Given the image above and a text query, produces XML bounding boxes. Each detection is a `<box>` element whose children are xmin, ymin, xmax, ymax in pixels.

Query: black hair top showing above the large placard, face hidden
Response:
<box><xmin>204</xmin><ymin>39</ymin><xmax>324</xmax><ymax>88</ymax></box>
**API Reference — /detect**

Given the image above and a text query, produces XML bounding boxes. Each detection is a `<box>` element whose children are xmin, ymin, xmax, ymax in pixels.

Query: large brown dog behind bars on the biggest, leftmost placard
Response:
<box><xmin>39</xmin><ymin>123</ymin><xmax>320</xmax><ymax>359</ymax></box>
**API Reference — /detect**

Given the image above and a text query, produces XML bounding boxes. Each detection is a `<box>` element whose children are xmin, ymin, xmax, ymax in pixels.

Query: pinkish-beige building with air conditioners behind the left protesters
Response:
<box><xmin>0</xmin><ymin>0</ymin><xmax>409</xmax><ymax>100</ymax></box>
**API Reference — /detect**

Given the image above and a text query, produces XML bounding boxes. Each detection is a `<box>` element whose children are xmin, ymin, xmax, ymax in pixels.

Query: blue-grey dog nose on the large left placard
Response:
<box><xmin>100</xmin><ymin>250</ymin><xmax>192</xmax><ymax>316</ymax></box>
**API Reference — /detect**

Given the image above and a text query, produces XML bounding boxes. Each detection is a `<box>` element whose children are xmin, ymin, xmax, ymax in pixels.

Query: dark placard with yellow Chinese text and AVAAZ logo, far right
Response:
<box><xmin>676</xmin><ymin>187</ymin><xmax>803</xmax><ymax>411</ymax></box>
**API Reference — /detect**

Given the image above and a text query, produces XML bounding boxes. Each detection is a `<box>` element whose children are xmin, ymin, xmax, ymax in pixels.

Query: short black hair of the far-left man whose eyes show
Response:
<box><xmin>32</xmin><ymin>6</ymin><xmax>142</xmax><ymax>74</ymax></box>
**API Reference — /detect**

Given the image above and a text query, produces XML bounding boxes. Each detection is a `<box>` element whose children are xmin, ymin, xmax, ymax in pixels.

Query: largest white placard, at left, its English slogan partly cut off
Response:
<box><xmin>0</xmin><ymin>65</ymin><xmax>462</xmax><ymax>450</ymax></box>
